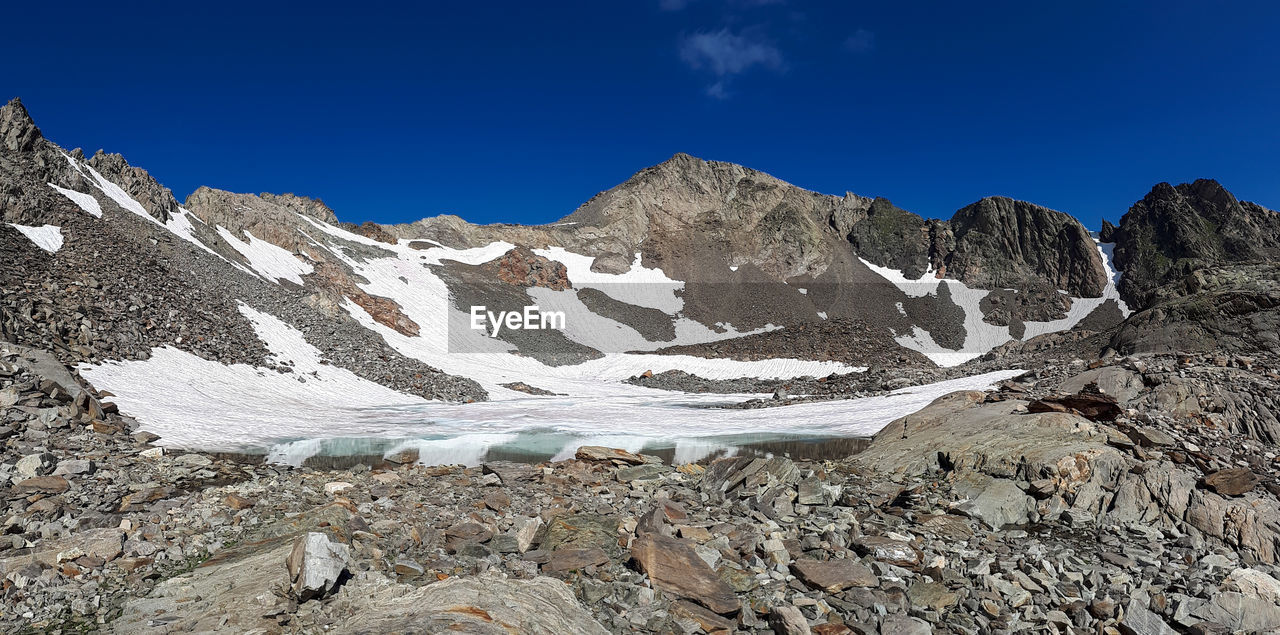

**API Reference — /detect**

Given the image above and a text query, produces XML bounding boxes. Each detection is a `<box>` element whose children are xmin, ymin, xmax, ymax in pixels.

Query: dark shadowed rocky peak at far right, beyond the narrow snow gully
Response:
<box><xmin>1110</xmin><ymin>179</ymin><xmax>1280</xmax><ymax>307</ymax></box>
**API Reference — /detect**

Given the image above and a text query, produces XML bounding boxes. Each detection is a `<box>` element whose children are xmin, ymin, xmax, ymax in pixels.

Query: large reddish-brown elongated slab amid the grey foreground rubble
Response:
<box><xmin>631</xmin><ymin>534</ymin><xmax>741</xmax><ymax>615</ymax></box>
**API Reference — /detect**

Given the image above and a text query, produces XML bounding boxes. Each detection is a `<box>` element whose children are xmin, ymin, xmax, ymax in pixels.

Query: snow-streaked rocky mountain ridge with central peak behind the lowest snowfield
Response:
<box><xmin>0</xmin><ymin>101</ymin><xmax>1136</xmax><ymax>386</ymax></box>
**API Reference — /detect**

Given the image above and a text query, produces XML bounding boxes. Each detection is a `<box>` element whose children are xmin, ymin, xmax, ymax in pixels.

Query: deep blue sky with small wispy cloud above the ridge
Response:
<box><xmin>0</xmin><ymin>0</ymin><xmax>1280</xmax><ymax>227</ymax></box>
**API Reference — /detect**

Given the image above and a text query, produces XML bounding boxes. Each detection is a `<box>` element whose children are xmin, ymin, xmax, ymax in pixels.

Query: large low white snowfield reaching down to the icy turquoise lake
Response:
<box><xmin>79</xmin><ymin>299</ymin><xmax>1020</xmax><ymax>465</ymax></box>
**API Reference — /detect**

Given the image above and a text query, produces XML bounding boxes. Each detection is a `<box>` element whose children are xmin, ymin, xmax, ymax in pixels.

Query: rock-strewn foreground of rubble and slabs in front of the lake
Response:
<box><xmin>0</xmin><ymin>337</ymin><xmax>1280</xmax><ymax>632</ymax></box>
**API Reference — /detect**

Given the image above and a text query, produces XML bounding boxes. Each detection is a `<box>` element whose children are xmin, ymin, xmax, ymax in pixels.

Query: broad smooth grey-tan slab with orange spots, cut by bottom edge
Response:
<box><xmin>329</xmin><ymin>576</ymin><xmax>608</xmax><ymax>635</ymax></box>
